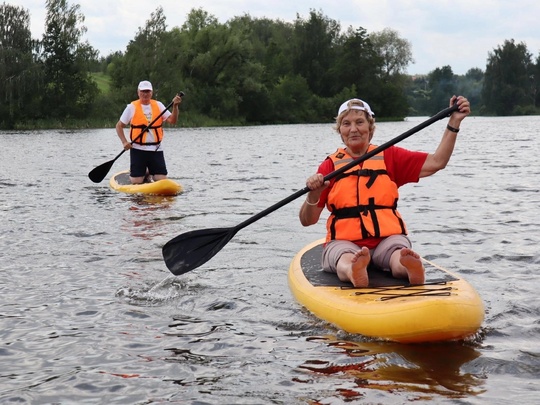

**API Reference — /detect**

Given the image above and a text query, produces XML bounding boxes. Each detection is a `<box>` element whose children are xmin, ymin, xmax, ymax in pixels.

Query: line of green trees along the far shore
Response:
<box><xmin>0</xmin><ymin>0</ymin><xmax>540</xmax><ymax>129</ymax></box>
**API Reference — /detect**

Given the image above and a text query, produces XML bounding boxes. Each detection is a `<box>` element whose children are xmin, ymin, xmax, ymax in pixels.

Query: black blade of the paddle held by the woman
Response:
<box><xmin>162</xmin><ymin>228</ymin><xmax>237</xmax><ymax>276</ymax></box>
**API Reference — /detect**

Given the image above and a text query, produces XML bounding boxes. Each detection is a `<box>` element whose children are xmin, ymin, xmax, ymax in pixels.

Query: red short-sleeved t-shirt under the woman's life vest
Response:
<box><xmin>317</xmin><ymin>146</ymin><xmax>428</xmax><ymax>249</ymax></box>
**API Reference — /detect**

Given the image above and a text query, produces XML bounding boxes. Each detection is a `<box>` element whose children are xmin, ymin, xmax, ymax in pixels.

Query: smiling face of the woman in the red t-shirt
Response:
<box><xmin>338</xmin><ymin>110</ymin><xmax>375</xmax><ymax>156</ymax></box>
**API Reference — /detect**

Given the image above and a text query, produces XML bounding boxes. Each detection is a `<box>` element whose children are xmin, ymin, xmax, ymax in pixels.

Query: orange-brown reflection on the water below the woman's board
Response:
<box><xmin>299</xmin><ymin>336</ymin><xmax>485</xmax><ymax>400</ymax></box>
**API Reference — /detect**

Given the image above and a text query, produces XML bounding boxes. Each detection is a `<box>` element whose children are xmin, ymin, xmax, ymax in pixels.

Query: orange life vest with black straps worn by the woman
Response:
<box><xmin>326</xmin><ymin>145</ymin><xmax>407</xmax><ymax>242</ymax></box>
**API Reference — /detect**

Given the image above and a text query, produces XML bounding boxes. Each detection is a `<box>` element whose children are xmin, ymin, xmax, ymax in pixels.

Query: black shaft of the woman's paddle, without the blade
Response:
<box><xmin>232</xmin><ymin>104</ymin><xmax>458</xmax><ymax>233</ymax></box>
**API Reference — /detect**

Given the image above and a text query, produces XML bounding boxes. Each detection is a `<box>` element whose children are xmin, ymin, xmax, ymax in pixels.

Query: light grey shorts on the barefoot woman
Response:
<box><xmin>322</xmin><ymin>235</ymin><xmax>412</xmax><ymax>273</ymax></box>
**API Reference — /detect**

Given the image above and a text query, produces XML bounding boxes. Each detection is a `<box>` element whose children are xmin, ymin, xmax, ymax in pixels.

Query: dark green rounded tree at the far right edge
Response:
<box><xmin>482</xmin><ymin>39</ymin><xmax>535</xmax><ymax>115</ymax></box>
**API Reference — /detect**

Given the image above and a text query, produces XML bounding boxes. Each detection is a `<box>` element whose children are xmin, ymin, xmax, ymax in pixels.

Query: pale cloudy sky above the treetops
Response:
<box><xmin>7</xmin><ymin>0</ymin><xmax>540</xmax><ymax>74</ymax></box>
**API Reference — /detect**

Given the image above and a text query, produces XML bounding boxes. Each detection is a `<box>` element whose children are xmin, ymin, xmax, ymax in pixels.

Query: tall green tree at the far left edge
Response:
<box><xmin>0</xmin><ymin>3</ymin><xmax>43</xmax><ymax>129</ymax></box>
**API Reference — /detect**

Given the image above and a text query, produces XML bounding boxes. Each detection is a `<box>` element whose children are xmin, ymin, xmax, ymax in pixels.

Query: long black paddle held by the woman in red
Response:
<box><xmin>162</xmin><ymin>104</ymin><xmax>458</xmax><ymax>276</ymax></box>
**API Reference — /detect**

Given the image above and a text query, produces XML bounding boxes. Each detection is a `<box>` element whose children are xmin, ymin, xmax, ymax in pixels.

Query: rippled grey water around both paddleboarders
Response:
<box><xmin>0</xmin><ymin>117</ymin><xmax>540</xmax><ymax>405</ymax></box>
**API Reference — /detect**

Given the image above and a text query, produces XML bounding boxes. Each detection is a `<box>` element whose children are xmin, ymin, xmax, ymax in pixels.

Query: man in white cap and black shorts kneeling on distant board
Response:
<box><xmin>116</xmin><ymin>80</ymin><xmax>183</xmax><ymax>184</ymax></box>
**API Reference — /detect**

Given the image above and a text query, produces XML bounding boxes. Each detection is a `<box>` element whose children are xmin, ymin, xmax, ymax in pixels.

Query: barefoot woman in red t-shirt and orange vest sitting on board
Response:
<box><xmin>299</xmin><ymin>96</ymin><xmax>471</xmax><ymax>287</ymax></box>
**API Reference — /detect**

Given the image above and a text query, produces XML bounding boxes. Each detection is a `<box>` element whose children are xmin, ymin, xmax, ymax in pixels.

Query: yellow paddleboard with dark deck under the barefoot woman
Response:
<box><xmin>288</xmin><ymin>239</ymin><xmax>484</xmax><ymax>343</ymax></box>
